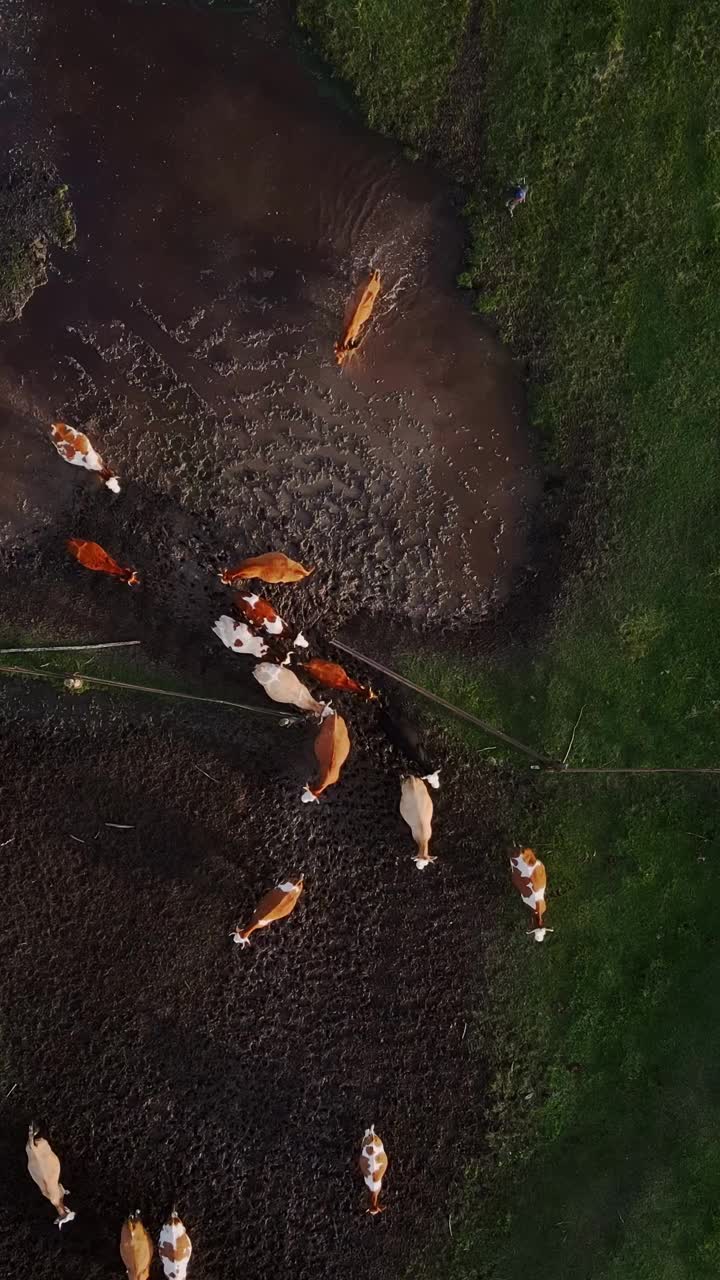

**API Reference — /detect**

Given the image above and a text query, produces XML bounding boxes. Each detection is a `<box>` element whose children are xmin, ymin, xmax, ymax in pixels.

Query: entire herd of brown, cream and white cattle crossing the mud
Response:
<box><xmin>27</xmin><ymin>404</ymin><xmax>552</xmax><ymax>1264</ymax></box>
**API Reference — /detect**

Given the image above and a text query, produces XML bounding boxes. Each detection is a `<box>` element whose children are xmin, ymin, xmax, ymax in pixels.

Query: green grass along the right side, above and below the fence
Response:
<box><xmin>302</xmin><ymin>0</ymin><xmax>720</xmax><ymax>1280</ymax></box>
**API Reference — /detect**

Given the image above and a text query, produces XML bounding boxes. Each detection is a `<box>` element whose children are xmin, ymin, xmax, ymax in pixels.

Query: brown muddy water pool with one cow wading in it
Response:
<box><xmin>0</xmin><ymin>0</ymin><xmax>534</xmax><ymax>637</ymax></box>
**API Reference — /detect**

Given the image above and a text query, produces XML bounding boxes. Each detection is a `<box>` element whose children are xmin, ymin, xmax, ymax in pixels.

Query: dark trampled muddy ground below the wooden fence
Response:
<box><xmin>0</xmin><ymin>686</ymin><xmax>515</xmax><ymax>1280</ymax></box>
